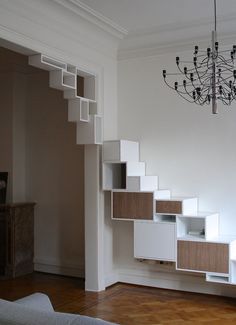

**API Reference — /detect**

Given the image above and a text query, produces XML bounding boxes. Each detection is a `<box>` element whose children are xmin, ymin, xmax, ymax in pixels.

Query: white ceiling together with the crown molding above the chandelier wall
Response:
<box><xmin>77</xmin><ymin>0</ymin><xmax>236</xmax><ymax>58</ymax></box>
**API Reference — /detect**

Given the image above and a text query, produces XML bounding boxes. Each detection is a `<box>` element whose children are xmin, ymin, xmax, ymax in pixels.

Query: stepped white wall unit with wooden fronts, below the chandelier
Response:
<box><xmin>103</xmin><ymin>140</ymin><xmax>236</xmax><ymax>284</ymax></box>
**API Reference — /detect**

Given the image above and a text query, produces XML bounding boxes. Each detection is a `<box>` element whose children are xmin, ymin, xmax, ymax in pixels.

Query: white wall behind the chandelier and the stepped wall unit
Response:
<box><xmin>116</xmin><ymin>53</ymin><xmax>236</xmax><ymax>291</ymax></box>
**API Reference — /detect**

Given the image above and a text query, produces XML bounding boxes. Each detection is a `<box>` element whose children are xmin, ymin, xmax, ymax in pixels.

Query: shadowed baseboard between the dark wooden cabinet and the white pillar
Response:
<box><xmin>34</xmin><ymin>259</ymin><xmax>85</xmax><ymax>278</ymax></box>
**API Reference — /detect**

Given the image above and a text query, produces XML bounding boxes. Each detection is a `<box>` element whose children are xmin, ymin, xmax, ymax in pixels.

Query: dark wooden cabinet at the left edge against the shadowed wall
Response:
<box><xmin>0</xmin><ymin>203</ymin><xmax>35</xmax><ymax>277</ymax></box>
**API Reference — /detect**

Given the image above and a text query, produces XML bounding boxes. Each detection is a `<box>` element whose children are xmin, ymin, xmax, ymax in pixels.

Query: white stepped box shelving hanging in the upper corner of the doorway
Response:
<box><xmin>29</xmin><ymin>54</ymin><xmax>102</xmax><ymax>144</ymax></box>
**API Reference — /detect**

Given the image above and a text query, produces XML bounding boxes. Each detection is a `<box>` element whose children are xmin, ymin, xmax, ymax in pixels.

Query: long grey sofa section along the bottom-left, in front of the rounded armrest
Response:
<box><xmin>0</xmin><ymin>299</ymin><xmax>116</xmax><ymax>325</ymax></box>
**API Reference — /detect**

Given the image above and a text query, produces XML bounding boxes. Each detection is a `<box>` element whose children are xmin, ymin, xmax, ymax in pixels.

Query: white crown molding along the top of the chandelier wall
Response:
<box><xmin>118</xmin><ymin>14</ymin><xmax>236</xmax><ymax>60</ymax></box>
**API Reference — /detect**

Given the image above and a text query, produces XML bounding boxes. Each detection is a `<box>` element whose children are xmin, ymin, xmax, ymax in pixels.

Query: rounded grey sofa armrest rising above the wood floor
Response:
<box><xmin>15</xmin><ymin>292</ymin><xmax>54</xmax><ymax>311</ymax></box>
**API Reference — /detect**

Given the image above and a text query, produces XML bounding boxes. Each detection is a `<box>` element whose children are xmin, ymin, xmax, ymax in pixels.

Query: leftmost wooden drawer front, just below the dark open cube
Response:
<box><xmin>113</xmin><ymin>192</ymin><xmax>154</xmax><ymax>220</ymax></box>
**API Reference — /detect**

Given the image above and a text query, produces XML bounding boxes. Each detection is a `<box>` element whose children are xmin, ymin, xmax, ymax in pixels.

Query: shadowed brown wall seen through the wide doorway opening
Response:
<box><xmin>0</xmin><ymin>49</ymin><xmax>84</xmax><ymax>275</ymax></box>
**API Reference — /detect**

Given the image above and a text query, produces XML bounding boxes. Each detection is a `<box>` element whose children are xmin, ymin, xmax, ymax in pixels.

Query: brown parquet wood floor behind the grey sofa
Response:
<box><xmin>0</xmin><ymin>273</ymin><xmax>236</xmax><ymax>325</ymax></box>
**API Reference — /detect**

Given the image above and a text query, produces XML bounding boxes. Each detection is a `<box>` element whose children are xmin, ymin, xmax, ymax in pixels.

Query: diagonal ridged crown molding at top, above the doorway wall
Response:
<box><xmin>52</xmin><ymin>0</ymin><xmax>128</xmax><ymax>39</ymax></box>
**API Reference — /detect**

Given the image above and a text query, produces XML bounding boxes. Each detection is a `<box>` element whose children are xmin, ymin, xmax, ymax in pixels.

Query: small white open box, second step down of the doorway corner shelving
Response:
<box><xmin>49</xmin><ymin>70</ymin><xmax>76</xmax><ymax>90</ymax></box>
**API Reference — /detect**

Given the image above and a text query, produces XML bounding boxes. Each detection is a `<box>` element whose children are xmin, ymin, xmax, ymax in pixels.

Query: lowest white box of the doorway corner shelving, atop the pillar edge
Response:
<box><xmin>76</xmin><ymin>115</ymin><xmax>103</xmax><ymax>144</ymax></box>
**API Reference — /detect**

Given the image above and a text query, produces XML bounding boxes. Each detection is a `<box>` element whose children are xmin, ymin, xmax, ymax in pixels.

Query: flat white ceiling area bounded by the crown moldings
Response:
<box><xmin>80</xmin><ymin>0</ymin><xmax>236</xmax><ymax>33</ymax></box>
